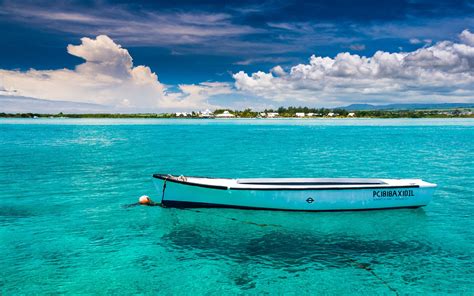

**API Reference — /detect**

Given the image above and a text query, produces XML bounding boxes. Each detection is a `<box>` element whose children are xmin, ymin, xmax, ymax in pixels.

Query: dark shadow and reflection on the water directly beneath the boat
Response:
<box><xmin>158</xmin><ymin>209</ymin><xmax>430</xmax><ymax>268</ymax></box>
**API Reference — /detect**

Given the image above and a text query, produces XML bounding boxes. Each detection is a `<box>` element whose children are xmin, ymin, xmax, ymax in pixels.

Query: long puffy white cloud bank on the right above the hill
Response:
<box><xmin>233</xmin><ymin>30</ymin><xmax>474</xmax><ymax>106</ymax></box>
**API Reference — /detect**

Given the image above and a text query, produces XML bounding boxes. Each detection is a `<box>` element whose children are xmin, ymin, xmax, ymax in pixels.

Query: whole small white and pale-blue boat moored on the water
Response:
<box><xmin>153</xmin><ymin>174</ymin><xmax>436</xmax><ymax>211</ymax></box>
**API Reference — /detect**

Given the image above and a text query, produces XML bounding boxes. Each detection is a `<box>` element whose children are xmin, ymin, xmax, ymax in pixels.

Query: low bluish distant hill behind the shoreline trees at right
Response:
<box><xmin>339</xmin><ymin>103</ymin><xmax>474</xmax><ymax>111</ymax></box>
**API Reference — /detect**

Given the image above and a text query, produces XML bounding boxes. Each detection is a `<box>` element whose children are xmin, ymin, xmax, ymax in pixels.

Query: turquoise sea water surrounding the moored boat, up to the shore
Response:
<box><xmin>0</xmin><ymin>119</ymin><xmax>474</xmax><ymax>295</ymax></box>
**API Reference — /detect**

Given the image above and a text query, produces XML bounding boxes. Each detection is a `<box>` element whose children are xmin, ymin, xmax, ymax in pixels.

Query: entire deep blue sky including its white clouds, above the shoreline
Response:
<box><xmin>0</xmin><ymin>0</ymin><xmax>474</xmax><ymax>111</ymax></box>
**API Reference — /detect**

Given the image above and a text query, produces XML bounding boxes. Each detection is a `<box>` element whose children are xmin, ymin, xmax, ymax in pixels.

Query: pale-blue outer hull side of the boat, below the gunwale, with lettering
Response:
<box><xmin>154</xmin><ymin>178</ymin><xmax>435</xmax><ymax>211</ymax></box>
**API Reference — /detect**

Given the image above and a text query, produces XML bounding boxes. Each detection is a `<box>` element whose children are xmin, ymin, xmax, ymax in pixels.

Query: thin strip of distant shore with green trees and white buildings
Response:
<box><xmin>0</xmin><ymin>107</ymin><xmax>474</xmax><ymax>118</ymax></box>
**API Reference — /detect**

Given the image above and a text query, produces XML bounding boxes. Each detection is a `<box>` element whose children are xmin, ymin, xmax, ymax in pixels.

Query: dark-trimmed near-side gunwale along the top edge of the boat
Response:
<box><xmin>153</xmin><ymin>174</ymin><xmax>420</xmax><ymax>191</ymax></box>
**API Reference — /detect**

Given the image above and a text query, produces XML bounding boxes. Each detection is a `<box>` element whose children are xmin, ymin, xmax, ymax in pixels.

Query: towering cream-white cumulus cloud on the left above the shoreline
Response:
<box><xmin>0</xmin><ymin>35</ymin><xmax>230</xmax><ymax>111</ymax></box>
